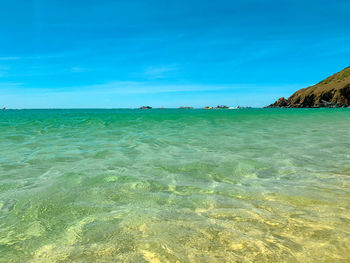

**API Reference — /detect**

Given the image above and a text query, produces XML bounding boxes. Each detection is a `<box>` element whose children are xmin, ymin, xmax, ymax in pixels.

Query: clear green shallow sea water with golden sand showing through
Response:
<box><xmin>0</xmin><ymin>109</ymin><xmax>350</xmax><ymax>262</ymax></box>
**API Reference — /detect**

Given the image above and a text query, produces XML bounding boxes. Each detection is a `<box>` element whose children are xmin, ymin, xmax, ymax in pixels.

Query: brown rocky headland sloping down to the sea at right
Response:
<box><xmin>268</xmin><ymin>67</ymin><xmax>350</xmax><ymax>108</ymax></box>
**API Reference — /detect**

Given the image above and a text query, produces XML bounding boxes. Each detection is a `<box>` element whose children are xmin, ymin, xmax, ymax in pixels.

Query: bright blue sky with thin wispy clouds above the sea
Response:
<box><xmin>0</xmin><ymin>0</ymin><xmax>350</xmax><ymax>108</ymax></box>
